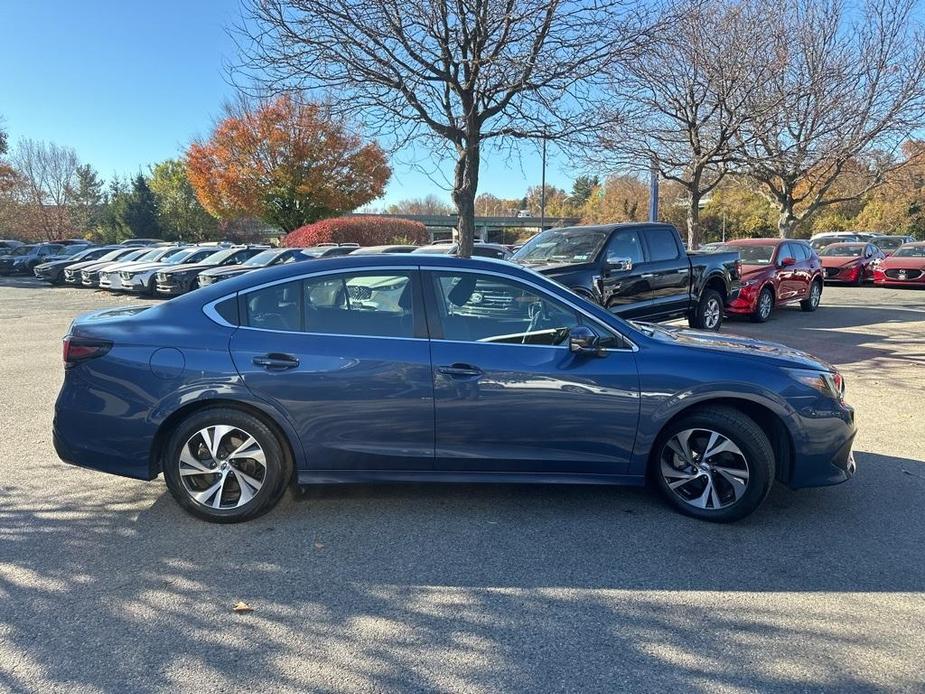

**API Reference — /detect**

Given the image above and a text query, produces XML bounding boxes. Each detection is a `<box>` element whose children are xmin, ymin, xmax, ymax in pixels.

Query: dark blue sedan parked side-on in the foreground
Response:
<box><xmin>54</xmin><ymin>254</ymin><xmax>855</xmax><ymax>522</ymax></box>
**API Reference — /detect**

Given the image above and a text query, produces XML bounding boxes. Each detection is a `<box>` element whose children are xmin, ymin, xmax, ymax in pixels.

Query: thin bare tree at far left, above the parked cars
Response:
<box><xmin>12</xmin><ymin>139</ymin><xmax>80</xmax><ymax>240</ymax></box>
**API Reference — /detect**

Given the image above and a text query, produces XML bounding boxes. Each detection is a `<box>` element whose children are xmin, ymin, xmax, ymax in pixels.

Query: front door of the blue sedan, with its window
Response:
<box><xmin>422</xmin><ymin>268</ymin><xmax>639</xmax><ymax>474</ymax></box>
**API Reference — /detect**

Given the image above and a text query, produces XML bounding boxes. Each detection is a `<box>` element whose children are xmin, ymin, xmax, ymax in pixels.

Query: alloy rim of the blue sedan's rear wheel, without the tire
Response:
<box><xmin>177</xmin><ymin>424</ymin><xmax>267</xmax><ymax>510</ymax></box>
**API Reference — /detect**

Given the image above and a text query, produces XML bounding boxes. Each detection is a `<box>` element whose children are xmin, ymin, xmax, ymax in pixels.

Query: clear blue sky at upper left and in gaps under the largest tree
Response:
<box><xmin>0</xmin><ymin>0</ymin><xmax>575</xmax><ymax>206</ymax></box>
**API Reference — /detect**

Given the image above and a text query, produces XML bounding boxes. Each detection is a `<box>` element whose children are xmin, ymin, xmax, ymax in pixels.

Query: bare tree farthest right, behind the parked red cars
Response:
<box><xmin>740</xmin><ymin>0</ymin><xmax>925</xmax><ymax>237</ymax></box>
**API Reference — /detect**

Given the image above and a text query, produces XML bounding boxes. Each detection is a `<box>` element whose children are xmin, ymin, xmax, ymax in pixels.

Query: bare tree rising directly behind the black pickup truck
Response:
<box><xmin>587</xmin><ymin>0</ymin><xmax>773</xmax><ymax>248</ymax></box>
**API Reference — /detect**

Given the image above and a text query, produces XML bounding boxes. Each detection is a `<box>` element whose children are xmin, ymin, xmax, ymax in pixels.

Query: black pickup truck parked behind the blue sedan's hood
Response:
<box><xmin>511</xmin><ymin>223</ymin><xmax>740</xmax><ymax>330</ymax></box>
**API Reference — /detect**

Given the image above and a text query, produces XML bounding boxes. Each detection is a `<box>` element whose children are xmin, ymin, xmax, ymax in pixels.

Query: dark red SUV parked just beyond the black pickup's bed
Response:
<box><xmin>721</xmin><ymin>239</ymin><xmax>823</xmax><ymax>323</ymax></box>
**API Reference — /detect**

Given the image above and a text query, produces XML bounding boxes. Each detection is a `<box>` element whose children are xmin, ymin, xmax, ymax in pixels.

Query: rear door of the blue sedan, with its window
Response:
<box><xmin>230</xmin><ymin>267</ymin><xmax>434</xmax><ymax>471</ymax></box>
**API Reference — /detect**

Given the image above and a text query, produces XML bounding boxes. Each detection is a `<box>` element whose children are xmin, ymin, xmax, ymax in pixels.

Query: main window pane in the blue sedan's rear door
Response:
<box><xmin>302</xmin><ymin>272</ymin><xmax>415</xmax><ymax>337</ymax></box>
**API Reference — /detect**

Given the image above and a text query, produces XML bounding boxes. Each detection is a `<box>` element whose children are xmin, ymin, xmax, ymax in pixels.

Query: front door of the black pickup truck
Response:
<box><xmin>597</xmin><ymin>227</ymin><xmax>652</xmax><ymax>318</ymax></box>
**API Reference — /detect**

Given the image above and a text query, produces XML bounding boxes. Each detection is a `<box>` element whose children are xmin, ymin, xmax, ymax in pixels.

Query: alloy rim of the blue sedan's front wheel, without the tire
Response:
<box><xmin>659</xmin><ymin>429</ymin><xmax>749</xmax><ymax>511</ymax></box>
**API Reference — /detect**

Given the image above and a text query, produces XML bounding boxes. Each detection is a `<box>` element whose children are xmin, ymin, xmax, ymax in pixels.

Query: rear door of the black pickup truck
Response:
<box><xmin>640</xmin><ymin>227</ymin><xmax>690</xmax><ymax>316</ymax></box>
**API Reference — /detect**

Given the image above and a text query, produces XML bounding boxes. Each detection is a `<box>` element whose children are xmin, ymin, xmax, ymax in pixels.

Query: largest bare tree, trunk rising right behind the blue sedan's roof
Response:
<box><xmin>241</xmin><ymin>0</ymin><xmax>651</xmax><ymax>255</ymax></box>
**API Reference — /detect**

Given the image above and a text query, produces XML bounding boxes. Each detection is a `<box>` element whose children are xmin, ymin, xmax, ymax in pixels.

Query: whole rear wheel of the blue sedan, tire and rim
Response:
<box><xmin>161</xmin><ymin>407</ymin><xmax>292</xmax><ymax>523</ymax></box>
